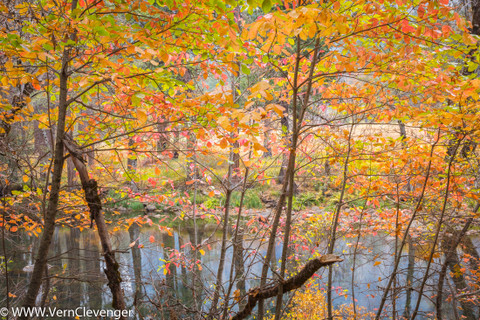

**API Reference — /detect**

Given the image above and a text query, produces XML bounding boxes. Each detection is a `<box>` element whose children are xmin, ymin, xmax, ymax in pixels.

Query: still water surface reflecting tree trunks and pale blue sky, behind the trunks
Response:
<box><xmin>0</xmin><ymin>224</ymin><xmax>476</xmax><ymax>319</ymax></box>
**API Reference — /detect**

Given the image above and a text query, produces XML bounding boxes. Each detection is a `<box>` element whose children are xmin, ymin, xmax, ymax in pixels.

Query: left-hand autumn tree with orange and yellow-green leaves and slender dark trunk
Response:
<box><xmin>2</xmin><ymin>1</ymin><xmax>244</xmax><ymax>316</ymax></box>
